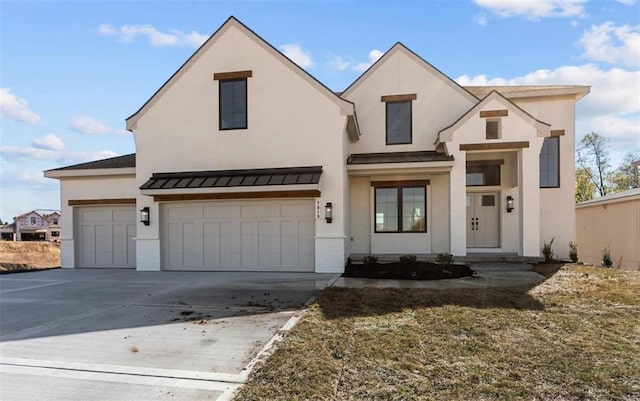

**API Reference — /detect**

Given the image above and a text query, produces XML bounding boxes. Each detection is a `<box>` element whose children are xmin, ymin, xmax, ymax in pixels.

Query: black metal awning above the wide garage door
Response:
<box><xmin>140</xmin><ymin>166</ymin><xmax>322</xmax><ymax>190</ymax></box>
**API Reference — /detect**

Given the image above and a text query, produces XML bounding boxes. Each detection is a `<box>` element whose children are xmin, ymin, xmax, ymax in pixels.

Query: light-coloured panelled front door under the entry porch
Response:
<box><xmin>467</xmin><ymin>192</ymin><xmax>500</xmax><ymax>248</ymax></box>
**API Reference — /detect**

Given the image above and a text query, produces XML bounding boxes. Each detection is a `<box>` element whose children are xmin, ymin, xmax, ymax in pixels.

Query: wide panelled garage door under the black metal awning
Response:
<box><xmin>161</xmin><ymin>200</ymin><xmax>315</xmax><ymax>272</ymax></box>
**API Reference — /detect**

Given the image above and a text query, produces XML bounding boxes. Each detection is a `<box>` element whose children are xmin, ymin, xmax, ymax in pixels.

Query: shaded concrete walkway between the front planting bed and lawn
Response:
<box><xmin>331</xmin><ymin>262</ymin><xmax>544</xmax><ymax>290</ymax></box>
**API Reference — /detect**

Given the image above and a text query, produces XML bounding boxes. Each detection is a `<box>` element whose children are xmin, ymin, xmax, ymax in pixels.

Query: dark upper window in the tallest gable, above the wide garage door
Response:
<box><xmin>219</xmin><ymin>78</ymin><xmax>247</xmax><ymax>130</ymax></box>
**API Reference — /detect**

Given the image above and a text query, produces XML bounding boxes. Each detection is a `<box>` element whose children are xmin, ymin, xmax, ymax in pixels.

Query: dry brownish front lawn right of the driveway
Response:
<box><xmin>235</xmin><ymin>265</ymin><xmax>640</xmax><ymax>401</ymax></box>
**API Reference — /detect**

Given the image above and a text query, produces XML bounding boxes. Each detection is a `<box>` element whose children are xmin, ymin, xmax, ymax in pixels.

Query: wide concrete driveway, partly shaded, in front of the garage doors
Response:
<box><xmin>0</xmin><ymin>269</ymin><xmax>335</xmax><ymax>401</ymax></box>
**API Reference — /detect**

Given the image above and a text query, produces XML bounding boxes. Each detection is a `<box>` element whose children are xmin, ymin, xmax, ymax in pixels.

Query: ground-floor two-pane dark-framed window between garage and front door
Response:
<box><xmin>374</xmin><ymin>186</ymin><xmax>427</xmax><ymax>233</ymax></box>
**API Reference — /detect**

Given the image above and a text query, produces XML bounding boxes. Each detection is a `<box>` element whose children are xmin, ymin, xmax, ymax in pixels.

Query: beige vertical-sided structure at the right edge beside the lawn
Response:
<box><xmin>576</xmin><ymin>188</ymin><xmax>640</xmax><ymax>270</ymax></box>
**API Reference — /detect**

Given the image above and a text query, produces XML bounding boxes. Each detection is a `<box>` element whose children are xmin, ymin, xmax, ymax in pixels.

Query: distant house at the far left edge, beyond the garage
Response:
<box><xmin>0</xmin><ymin>210</ymin><xmax>62</xmax><ymax>242</ymax></box>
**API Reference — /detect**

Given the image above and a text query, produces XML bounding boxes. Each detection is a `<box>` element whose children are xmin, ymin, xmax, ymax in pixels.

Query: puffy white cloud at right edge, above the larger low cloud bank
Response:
<box><xmin>580</xmin><ymin>22</ymin><xmax>640</xmax><ymax>67</ymax></box>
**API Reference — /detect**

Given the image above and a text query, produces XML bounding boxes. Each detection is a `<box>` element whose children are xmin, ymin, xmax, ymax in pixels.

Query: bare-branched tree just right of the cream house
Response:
<box><xmin>577</xmin><ymin>132</ymin><xmax>611</xmax><ymax>196</ymax></box>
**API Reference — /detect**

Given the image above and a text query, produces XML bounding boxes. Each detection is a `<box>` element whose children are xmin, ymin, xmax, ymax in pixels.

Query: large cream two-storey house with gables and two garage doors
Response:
<box><xmin>45</xmin><ymin>17</ymin><xmax>589</xmax><ymax>272</ymax></box>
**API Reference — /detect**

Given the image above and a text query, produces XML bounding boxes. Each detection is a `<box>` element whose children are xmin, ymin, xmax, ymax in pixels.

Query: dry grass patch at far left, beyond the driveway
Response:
<box><xmin>0</xmin><ymin>241</ymin><xmax>60</xmax><ymax>273</ymax></box>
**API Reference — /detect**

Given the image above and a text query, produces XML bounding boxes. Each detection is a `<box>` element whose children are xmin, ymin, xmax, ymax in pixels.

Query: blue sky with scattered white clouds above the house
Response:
<box><xmin>0</xmin><ymin>0</ymin><xmax>640</xmax><ymax>221</ymax></box>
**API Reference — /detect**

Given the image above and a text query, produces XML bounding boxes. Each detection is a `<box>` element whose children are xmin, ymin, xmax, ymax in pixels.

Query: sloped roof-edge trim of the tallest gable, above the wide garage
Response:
<box><xmin>126</xmin><ymin>16</ymin><xmax>354</xmax><ymax>131</ymax></box>
